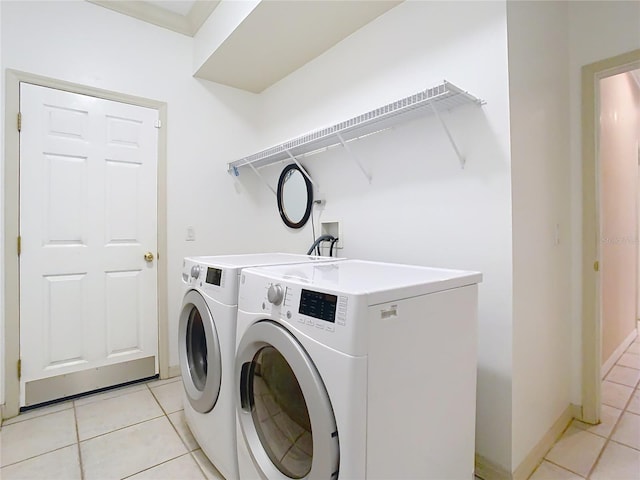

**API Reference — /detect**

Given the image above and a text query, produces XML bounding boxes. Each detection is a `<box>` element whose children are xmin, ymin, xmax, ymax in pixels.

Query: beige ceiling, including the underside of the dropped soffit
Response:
<box><xmin>87</xmin><ymin>0</ymin><xmax>403</xmax><ymax>93</ymax></box>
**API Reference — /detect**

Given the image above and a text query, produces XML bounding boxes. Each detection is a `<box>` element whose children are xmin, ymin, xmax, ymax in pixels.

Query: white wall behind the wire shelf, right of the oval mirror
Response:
<box><xmin>258</xmin><ymin>2</ymin><xmax>512</xmax><ymax>469</ymax></box>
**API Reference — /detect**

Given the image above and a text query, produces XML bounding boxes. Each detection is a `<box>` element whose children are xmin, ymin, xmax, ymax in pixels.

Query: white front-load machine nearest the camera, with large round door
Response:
<box><xmin>235</xmin><ymin>260</ymin><xmax>481</xmax><ymax>480</ymax></box>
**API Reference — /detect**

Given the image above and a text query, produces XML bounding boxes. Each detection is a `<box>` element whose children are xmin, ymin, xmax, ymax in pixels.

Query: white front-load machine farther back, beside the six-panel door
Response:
<box><xmin>178</xmin><ymin>253</ymin><xmax>336</xmax><ymax>480</ymax></box>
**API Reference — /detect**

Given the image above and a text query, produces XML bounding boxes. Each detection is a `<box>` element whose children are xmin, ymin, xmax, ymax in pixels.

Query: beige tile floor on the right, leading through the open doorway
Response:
<box><xmin>529</xmin><ymin>337</ymin><xmax>640</xmax><ymax>480</ymax></box>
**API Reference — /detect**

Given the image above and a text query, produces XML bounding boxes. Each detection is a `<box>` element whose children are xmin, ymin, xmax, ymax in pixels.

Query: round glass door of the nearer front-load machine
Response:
<box><xmin>236</xmin><ymin>320</ymin><xmax>340</xmax><ymax>480</ymax></box>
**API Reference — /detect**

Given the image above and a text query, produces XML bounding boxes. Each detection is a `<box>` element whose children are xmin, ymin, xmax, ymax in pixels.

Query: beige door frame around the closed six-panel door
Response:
<box><xmin>0</xmin><ymin>69</ymin><xmax>169</xmax><ymax>418</ymax></box>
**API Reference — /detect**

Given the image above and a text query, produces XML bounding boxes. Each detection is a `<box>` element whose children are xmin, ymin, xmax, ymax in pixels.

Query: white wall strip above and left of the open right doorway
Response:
<box><xmin>568</xmin><ymin>1</ymin><xmax>640</xmax><ymax>405</ymax></box>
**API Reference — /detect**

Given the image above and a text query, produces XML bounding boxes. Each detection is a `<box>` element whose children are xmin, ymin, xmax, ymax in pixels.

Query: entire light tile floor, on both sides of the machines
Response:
<box><xmin>0</xmin><ymin>338</ymin><xmax>640</xmax><ymax>480</ymax></box>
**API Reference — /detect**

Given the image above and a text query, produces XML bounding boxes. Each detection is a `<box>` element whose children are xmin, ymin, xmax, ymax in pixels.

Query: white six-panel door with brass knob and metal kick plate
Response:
<box><xmin>20</xmin><ymin>83</ymin><xmax>158</xmax><ymax>406</ymax></box>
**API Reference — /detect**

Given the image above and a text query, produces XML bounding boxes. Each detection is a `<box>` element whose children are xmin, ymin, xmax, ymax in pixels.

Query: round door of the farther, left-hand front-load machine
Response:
<box><xmin>178</xmin><ymin>290</ymin><xmax>222</xmax><ymax>413</ymax></box>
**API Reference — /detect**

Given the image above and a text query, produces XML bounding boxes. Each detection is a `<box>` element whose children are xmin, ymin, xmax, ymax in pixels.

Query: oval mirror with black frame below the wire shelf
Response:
<box><xmin>277</xmin><ymin>163</ymin><xmax>313</xmax><ymax>228</ymax></box>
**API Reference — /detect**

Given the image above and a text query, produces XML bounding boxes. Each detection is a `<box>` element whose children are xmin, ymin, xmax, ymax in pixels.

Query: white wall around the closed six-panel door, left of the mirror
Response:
<box><xmin>0</xmin><ymin>1</ymin><xmax>311</xmax><ymax>400</ymax></box>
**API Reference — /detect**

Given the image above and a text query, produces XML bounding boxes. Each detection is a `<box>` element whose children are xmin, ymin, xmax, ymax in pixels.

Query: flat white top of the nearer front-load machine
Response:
<box><xmin>244</xmin><ymin>260</ymin><xmax>482</xmax><ymax>305</ymax></box>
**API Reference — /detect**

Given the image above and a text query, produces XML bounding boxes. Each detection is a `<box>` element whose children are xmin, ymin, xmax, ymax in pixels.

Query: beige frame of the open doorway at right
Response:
<box><xmin>581</xmin><ymin>49</ymin><xmax>640</xmax><ymax>424</ymax></box>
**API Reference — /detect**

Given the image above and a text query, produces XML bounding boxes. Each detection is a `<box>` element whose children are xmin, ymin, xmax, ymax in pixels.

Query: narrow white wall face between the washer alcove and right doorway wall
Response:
<box><xmin>507</xmin><ymin>1</ymin><xmax>571</xmax><ymax>470</ymax></box>
